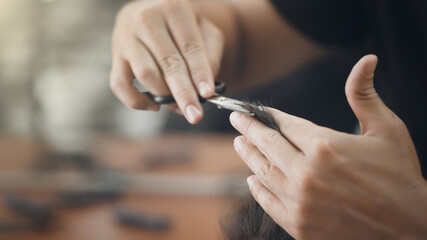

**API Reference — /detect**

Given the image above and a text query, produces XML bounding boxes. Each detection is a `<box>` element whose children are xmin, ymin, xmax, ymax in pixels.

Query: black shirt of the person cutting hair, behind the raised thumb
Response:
<box><xmin>271</xmin><ymin>0</ymin><xmax>427</xmax><ymax>178</ymax></box>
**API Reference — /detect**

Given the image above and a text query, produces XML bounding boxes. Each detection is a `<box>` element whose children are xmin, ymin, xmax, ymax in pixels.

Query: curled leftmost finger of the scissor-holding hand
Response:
<box><xmin>110</xmin><ymin>59</ymin><xmax>160</xmax><ymax>111</ymax></box>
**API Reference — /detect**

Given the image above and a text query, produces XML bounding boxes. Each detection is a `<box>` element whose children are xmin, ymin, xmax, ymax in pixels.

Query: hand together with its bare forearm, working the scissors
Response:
<box><xmin>110</xmin><ymin>0</ymin><xmax>324</xmax><ymax>124</ymax></box>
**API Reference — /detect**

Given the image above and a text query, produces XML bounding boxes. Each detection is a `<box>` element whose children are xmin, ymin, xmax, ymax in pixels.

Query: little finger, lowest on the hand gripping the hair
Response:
<box><xmin>247</xmin><ymin>176</ymin><xmax>289</xmax><ymax>230</ymax></box>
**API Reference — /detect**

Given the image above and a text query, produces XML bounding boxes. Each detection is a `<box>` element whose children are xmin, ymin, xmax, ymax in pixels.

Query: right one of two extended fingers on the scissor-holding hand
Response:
<box><xmin>165</xmin><ymin>0</ymin><xmax>215</xmax><ymax>98</ymax></box>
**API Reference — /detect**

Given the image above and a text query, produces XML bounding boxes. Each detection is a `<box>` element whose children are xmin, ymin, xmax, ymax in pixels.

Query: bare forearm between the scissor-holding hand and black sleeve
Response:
<box><xmin>195</xmin><ymin>0</ymin><xmax>325</xmax><ymax>88</ymax></box>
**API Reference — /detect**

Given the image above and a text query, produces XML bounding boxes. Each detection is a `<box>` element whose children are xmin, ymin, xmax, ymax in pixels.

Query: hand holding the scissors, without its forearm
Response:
<box><xmin>110</xmin><ymin>0</ymin><xmax>224</xmax><ymax>124</ymax></box>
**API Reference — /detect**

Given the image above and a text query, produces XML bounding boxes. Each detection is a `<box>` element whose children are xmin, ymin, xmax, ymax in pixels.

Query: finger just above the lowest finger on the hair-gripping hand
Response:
<box><xmin>234</xmin><ymin>136</ymin><xmax>287</xmax><ymax>196</ymax></box>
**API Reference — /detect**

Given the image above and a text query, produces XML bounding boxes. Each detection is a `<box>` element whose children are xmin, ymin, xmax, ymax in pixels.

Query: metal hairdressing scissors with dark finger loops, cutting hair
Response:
<box><xmin>142</xmin><ymin>81</ymin><xmax>254</xmax><ymax>116</ymax></box>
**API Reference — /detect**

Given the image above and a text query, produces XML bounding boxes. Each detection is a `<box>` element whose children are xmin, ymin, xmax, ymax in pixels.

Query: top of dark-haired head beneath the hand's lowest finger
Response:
<box><xmin>220</xmin><ymin>194</ymin><xmax>293</xmax><ymax>240</ymax></box>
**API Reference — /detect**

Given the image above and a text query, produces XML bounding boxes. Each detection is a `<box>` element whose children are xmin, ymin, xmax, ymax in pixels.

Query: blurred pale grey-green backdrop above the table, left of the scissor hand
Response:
<box><xmin>0</xmin><ymin>0</ymin><xmax>171</xmax><ymax>148</ymax></box>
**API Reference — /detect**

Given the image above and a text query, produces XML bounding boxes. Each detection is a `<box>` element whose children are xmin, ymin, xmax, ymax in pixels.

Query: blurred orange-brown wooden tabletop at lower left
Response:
<box><xmin>0</xmin><ymin>135</ymin><xmax>248</xmax><ymax>240</ymax></box>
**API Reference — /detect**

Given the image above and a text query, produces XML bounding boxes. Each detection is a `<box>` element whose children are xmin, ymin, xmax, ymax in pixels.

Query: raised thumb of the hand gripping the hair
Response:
<box><xmin>345</xmin><ymin>55</ymin><xmax>388</xmax><ymax>134</ymax></box>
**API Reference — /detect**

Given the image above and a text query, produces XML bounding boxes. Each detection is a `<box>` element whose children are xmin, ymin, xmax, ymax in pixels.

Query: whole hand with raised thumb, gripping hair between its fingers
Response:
<box><xmin>230</xmin><ymin>55</ymin><xmax>427</xmax><ymax>239</ymax></box>
